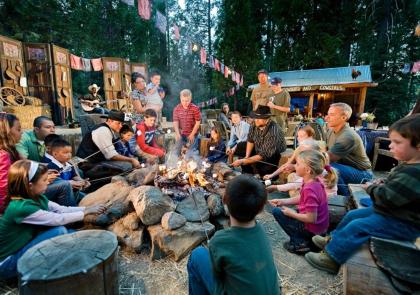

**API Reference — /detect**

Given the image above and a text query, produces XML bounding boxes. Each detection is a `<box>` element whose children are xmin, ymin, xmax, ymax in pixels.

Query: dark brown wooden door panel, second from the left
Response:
<box><xmin>23</xmin><ymin>43</ymin><xmax>54</xmax><ymax>107</ymax></box>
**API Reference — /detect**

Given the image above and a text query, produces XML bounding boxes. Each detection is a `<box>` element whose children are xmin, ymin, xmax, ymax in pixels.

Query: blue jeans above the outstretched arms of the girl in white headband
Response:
<box><xmin>45</xmin><ymin>178</ymin><xmax>77</xmax><ymax>206</ymax></box>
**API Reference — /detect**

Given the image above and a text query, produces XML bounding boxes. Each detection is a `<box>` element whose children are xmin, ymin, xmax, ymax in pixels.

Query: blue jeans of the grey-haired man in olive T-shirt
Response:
<box><xmin>331</xmin><ymin>163</ymin><xmax>373</xmax><ymax>197</ymax></box>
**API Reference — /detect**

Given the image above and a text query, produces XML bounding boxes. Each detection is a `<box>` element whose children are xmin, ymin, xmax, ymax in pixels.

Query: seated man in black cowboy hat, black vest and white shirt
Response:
<box><xmin>77</xmin><ymin>110</ymin><xmax>140</xmax><ymax>179</ymax></box>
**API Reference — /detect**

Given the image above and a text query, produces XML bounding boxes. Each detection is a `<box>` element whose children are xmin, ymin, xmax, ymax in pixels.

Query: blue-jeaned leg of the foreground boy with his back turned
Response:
<box><xmin>187</xmin><ymin>247</ymin><xmax>214</xmax><ymax>295</ymax></box>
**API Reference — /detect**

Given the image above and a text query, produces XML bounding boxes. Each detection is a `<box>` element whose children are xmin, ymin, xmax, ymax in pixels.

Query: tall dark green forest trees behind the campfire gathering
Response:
<box><xmin>0</xmin><ymin>0</ymin><xmax>420</xmax><ymax>125</ymax></box>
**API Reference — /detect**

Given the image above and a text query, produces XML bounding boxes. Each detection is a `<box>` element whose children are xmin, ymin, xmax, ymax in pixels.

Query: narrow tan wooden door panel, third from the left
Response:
<box><xmin>51</xmin><ymin>44</ymin><xmax>74</xmax><ymax>124</ymax></box>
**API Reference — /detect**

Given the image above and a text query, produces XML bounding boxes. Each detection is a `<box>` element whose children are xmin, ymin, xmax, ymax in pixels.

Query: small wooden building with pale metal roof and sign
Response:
<box><xmin>248</xmin><ymin>66</ymin><xmax>378</xmax><ymax>116</ymax></box>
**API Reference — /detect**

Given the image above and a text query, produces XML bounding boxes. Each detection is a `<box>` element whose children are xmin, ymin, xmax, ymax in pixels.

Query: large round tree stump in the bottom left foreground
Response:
<box><xmin>18</xmin><ymin>230</ymin><xmax>119</xmax><ymax>295</ymax></box>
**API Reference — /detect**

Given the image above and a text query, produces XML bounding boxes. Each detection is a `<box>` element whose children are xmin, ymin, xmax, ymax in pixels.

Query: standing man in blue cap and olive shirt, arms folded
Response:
<box><xmin>267</xmin><ymin>78</ymin><xmax>290</xmax><ymax>132</ymax></box>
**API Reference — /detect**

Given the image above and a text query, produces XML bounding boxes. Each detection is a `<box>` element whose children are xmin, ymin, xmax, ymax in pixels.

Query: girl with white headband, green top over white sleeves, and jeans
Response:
<box><xmin>0</xmin><ymin>160</ymin><xmax>105</xmax><ymax>279</ymax></box>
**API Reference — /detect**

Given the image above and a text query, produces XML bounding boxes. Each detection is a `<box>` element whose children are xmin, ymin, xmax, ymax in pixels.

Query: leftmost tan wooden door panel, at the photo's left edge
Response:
<box><xmin>0</xmin><ymin>36</ymin><xmax>28</xmax><ymax>95</ymax></box>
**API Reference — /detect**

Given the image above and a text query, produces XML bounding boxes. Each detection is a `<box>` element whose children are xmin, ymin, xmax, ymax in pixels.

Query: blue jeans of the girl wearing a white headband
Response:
<box><xmin>0</xmin><ymin>226</ymin><xmax>68</xmax><ymax>279</ymax></box>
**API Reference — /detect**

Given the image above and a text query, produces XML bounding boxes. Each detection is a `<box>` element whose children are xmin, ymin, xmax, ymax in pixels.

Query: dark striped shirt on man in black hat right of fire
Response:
<box><xmin>248</xmin><ymin>120</ymin><xmax>286</xmax><ymax>164</ymax></box>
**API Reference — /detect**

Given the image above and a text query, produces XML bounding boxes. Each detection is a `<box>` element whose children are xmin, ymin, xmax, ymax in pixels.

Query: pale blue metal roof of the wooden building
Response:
<box><xmin>249</xmin><ymin>65</ymin><xmax>372</xmax><ymax>88</ymax></box>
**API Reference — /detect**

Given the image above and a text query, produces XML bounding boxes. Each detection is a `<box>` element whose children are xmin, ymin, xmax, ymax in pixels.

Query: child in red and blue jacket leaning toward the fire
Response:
<box><xmin>136</xmin><ymin>109</ymin><xmax>166</xmax><ymax>162</ymax></box>
